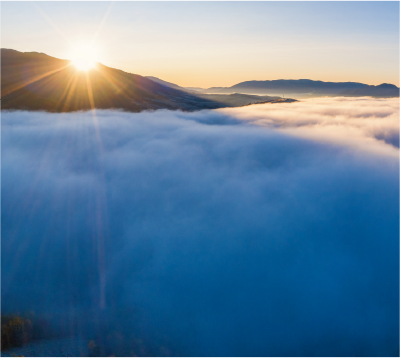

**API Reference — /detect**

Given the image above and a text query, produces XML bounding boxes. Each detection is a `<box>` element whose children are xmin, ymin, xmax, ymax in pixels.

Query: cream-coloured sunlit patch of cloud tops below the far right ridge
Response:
<box><xmin>220</xmin><ymin>98</ymin><xmax>400</xmax><ymax>157</ymax></box>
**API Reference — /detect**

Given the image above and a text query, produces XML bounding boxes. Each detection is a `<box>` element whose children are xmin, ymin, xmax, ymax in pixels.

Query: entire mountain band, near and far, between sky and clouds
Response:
<box><xmin>0</xmin><ymin>49</ymin><xmax>400</xmax><ymax>112</ymax></box>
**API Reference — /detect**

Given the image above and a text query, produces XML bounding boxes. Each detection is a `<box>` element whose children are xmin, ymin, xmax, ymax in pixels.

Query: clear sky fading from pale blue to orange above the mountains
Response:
<box><xmin>0</xmin><ymin>0</ymin><xmax>400</xmax><ymax>87</ymax></box>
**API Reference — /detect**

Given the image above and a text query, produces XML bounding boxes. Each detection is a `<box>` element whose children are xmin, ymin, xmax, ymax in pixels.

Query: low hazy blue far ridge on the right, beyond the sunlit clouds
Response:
<box><xmin>196</xmin><ymin>80</ymin><xmax>400</xmax><ymax>98</ymax></box>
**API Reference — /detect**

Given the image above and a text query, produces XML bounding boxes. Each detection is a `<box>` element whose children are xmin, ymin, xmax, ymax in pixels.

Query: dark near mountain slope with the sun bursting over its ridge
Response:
<box><xmin>0</xmin><ymin>49</ymin><xmax>294</xmax><ymax>112</ymax></box>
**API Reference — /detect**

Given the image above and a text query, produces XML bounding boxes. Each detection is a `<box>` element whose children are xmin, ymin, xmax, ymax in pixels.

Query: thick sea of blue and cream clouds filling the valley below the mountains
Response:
<box><xmin>0</xmin><ymin>98</ymin><xmax>400</xmax><ymax>358</ymax></box>
